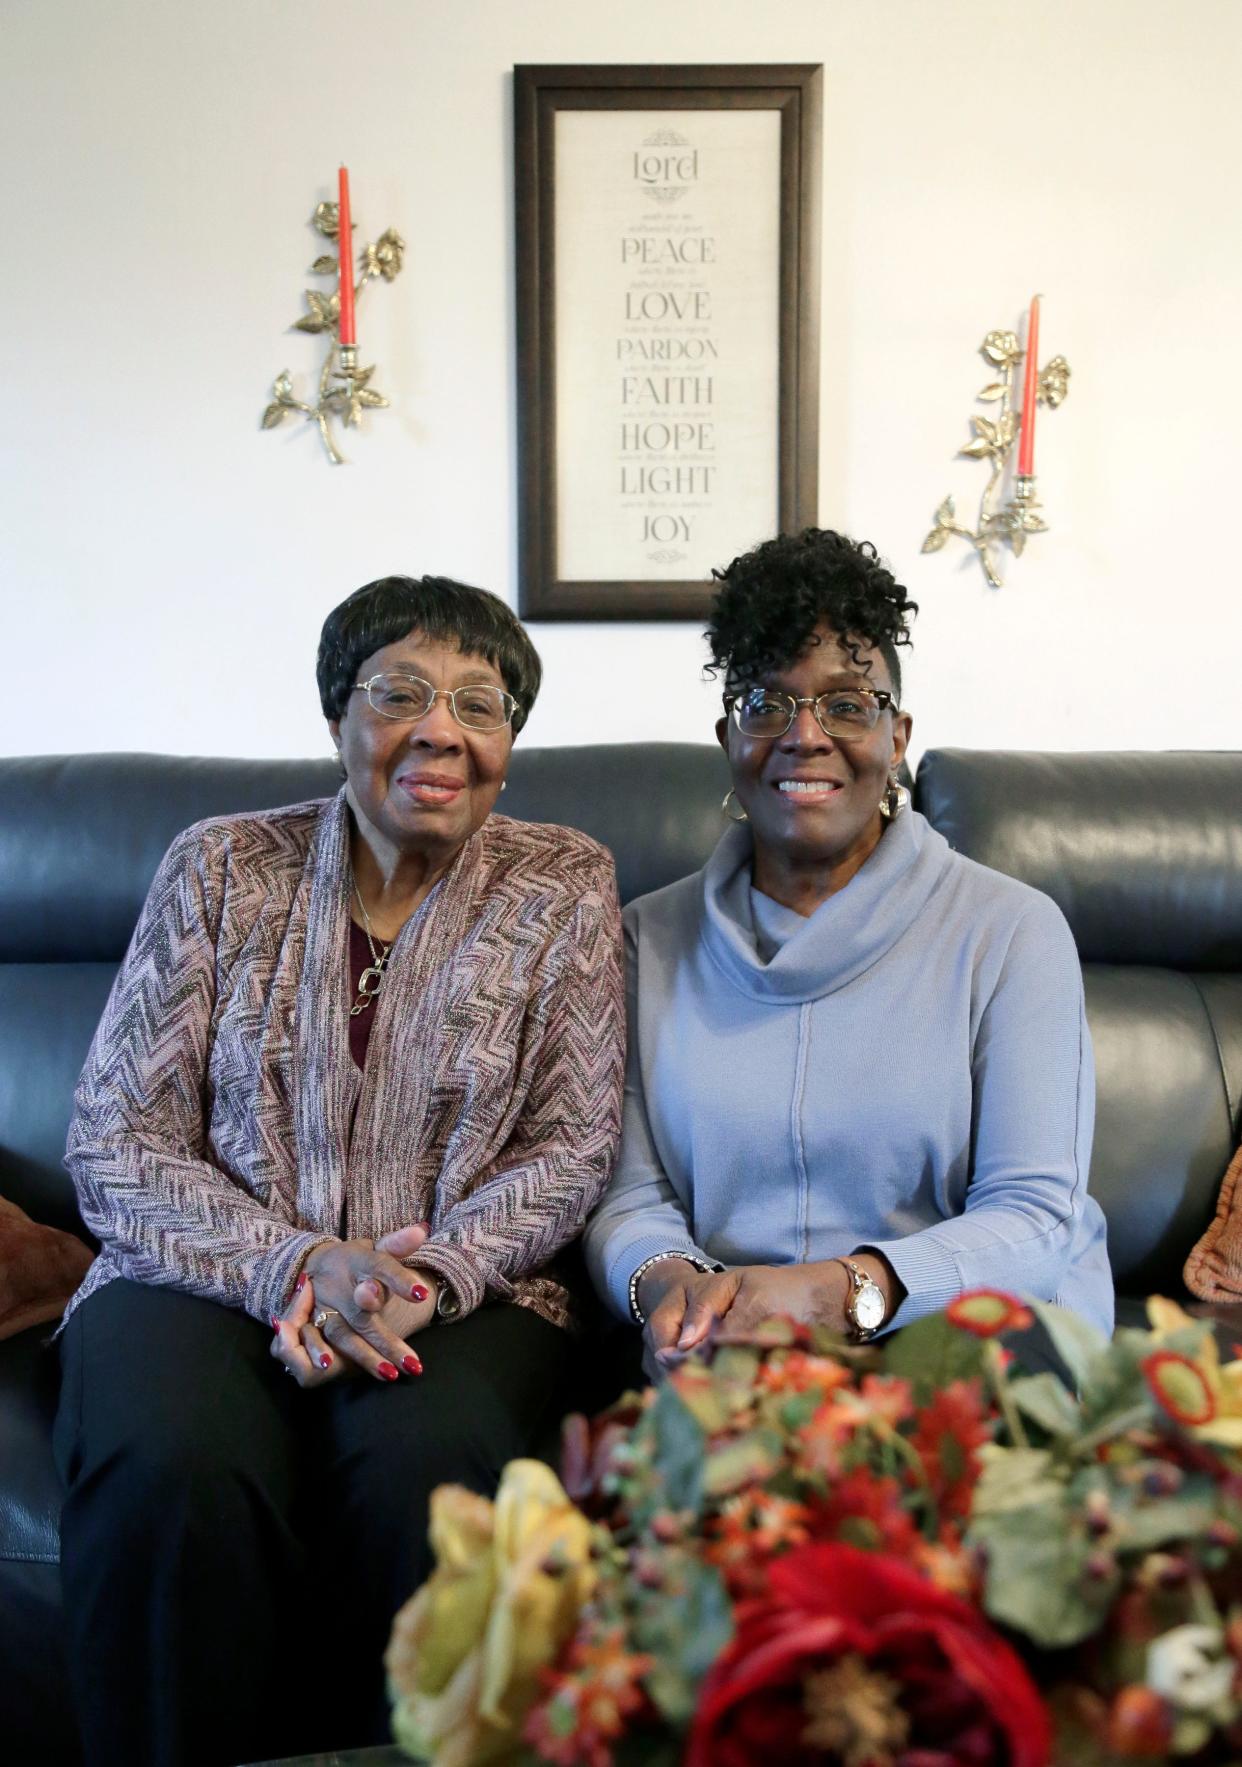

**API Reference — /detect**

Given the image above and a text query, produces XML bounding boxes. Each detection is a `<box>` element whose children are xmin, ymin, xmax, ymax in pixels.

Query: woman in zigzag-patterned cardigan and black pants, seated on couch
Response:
<box><xmin>57</xmin><ymin>578</ymin><xmax>624</xmax><ymax>1767</ymax></box>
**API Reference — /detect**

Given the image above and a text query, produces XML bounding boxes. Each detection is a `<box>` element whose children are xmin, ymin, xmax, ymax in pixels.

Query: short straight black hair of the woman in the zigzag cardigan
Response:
<box><xmin>314</xmin><ymin>576</ymin><xmax>544</xmax><ymax>735</ymax></box>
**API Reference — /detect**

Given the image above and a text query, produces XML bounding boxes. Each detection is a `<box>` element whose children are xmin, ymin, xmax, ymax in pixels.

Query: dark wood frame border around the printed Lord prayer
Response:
<box><xmin>514</xmin><ymin>65</ymin><xmax>823</xmax><ymax>620</ymax></box>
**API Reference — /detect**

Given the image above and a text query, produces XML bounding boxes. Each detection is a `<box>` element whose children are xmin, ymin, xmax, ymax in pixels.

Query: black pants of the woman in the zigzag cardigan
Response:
<box><xmin>55</xmin><ymin>1281</ymin><xmax>569</xmax><ymax>1767</ymax></box>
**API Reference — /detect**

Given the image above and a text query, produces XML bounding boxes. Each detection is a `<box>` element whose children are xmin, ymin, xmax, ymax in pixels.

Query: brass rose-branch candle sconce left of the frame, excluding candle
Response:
<box><xmin>263</xmin><ymin>203</ymin><xmax>405</xmax><ymax>466</ymax></box>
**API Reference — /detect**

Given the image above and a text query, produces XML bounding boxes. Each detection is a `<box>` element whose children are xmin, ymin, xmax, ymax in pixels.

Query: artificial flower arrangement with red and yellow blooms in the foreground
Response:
<box><xmin>387</xmin><ymin>1290</ymin><xmax>1242</xmax><ymax>1767</ymax></box>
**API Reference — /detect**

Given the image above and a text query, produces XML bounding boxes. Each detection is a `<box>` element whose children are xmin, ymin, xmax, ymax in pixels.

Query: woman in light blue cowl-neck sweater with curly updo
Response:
<box><xmin>587</xmin><ymin>528</ymin><xmax>1113</xmax><ymax>1366</ymax></box>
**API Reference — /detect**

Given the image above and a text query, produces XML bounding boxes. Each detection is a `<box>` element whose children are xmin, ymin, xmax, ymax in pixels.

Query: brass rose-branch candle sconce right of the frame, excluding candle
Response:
<box><xmin>922</xmin><ymin>330</ymin><xmax>1069</xmax><ymax>588</ymax></box>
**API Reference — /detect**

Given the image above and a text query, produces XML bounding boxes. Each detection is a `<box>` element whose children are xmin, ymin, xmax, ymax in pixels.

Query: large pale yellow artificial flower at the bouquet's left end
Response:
<box><xmin>385</xmin><ymin>1460</ymin><xmax>597</xmax><ymax>1767</ymax></box>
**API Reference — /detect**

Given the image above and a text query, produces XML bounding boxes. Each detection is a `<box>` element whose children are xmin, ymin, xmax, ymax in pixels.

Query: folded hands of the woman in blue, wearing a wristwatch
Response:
<box><xmin>638</xmin><ymin>1253</ymin><xmax>893</xmax><ymax>1371</ymax></box>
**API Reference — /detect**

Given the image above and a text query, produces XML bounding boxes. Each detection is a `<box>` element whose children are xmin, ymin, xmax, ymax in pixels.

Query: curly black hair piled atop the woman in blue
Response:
<box><xmin>703</xmin><ymin>528</ymin><xmax>919</xmax><ymax>705</ymax></box>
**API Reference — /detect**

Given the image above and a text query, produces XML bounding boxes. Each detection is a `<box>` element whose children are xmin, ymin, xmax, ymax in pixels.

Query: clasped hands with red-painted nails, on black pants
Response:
<box><xmin>272</xmin><ymin>1221</ymin><xmax>436</xmax><ymax>1387</ymax></box>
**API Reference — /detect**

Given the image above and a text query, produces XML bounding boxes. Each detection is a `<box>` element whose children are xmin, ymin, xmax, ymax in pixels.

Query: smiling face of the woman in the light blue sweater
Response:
<box><xmin>716</xmin><ymin>626</ymin><xmax>910</xmax><ymax>887</ymax></box>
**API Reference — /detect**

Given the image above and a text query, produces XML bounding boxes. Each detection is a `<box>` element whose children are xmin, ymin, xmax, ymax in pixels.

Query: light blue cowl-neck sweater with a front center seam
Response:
<box><xmin>587</xmin><ymin>809</ymin><xmax>1113</xmax><ymax>1331</ymax></box>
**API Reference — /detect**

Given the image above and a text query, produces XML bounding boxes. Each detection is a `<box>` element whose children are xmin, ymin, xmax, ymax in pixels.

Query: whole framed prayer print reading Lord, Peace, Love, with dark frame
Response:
<box><xmin>514</xmin><ymin>65</ymin><xmax>822</xmax><ymax>620</ymax></box>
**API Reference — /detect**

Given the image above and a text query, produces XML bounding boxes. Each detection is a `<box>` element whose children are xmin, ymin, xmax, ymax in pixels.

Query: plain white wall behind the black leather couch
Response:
<box><xmin>0</xmin><ymin>0</ymin><xmax>1242</xmax><ymax>755</ymax></box>
